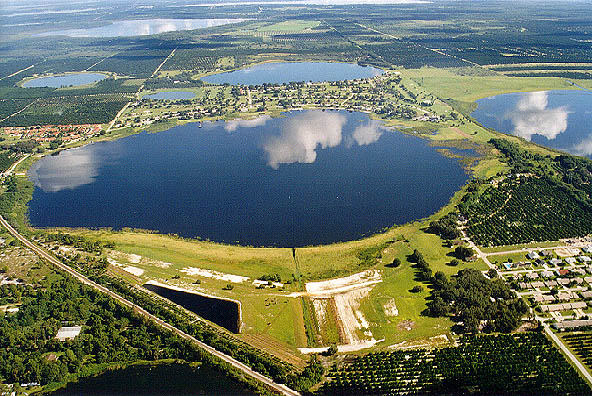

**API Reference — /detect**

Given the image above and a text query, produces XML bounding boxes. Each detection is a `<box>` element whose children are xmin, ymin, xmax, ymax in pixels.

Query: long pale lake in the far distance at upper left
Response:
<box><xmin>41</xmin><ymin>18</ymin><xmax>244</xmax><ymax>37</ymax></box>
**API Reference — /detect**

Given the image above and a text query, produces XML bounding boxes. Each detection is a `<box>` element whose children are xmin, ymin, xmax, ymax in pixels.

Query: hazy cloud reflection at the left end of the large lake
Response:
<box><xmin>29</xmin><ymin>147</ymin><xmax>98</xmax><ymax>192</ymax></box>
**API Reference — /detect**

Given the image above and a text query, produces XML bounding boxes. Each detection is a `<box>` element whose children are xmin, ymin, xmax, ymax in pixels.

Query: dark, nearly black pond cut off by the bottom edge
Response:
<box><xmin>50</xmin><ymin>363</ymin><xmax>254</xmax><ymax>396</ymax></box>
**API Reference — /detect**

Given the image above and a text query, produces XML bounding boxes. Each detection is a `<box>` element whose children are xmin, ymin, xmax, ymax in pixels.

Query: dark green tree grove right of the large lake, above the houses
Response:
<box><xmin>458</xmin><ymin>139</ymin><xmax>592</xmax><ymax>246</ymax></box>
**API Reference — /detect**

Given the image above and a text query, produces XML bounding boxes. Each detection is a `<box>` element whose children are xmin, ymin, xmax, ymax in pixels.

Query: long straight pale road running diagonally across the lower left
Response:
<box><xmin>0</xmin><ymin>216</ymin><xmax>300</xmax><ymax>396</ymax></box>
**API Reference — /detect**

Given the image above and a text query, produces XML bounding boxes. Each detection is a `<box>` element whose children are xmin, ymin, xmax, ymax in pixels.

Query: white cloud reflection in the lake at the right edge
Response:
<box><xmin>506</xmin><ymin>92</ymin><xmax>569</xmax><ymax>140</ymax></box>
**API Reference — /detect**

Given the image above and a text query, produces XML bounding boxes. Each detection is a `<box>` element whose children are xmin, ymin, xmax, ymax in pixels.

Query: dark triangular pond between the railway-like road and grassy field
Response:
<box><xmin>143</xmin><ymin>283</ymin><xmax>240</xmax><ymax>333</ymax></box>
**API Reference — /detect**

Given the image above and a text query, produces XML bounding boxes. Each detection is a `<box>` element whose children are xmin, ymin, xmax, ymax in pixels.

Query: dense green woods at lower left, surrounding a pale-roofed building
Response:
<box><xmin>0</xmin><ymin>273</ymin><xmax>206</xmax><ymax>384</ymax></box>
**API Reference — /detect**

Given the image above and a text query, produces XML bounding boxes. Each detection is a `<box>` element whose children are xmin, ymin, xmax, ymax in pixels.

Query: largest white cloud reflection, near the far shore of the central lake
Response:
<box><xmin>263</xmin><ymin>112</ymin><xmax>347</xmax><ymax>169</ymax></box>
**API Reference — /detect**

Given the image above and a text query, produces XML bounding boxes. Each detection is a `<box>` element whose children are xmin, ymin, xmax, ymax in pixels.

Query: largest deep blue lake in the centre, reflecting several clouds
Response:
<box><xmin>28</xmin><ymin>110</ymin><xmax>468</xmax><ymax>247</ymax></box>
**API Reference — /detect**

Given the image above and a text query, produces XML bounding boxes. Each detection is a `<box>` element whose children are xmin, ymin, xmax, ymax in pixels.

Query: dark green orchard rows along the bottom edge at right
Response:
<box><xmin>322</xmin><ymin>333</ymin><xmax>589</xmax><ymax>395</ymax></box>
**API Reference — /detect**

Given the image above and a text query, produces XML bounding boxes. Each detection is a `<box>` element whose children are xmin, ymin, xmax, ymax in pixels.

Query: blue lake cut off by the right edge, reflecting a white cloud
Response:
<box><xmin>471</xmin><ymin>90</ymin><xmax>592</xmax><ymax>158</ymax></box>
